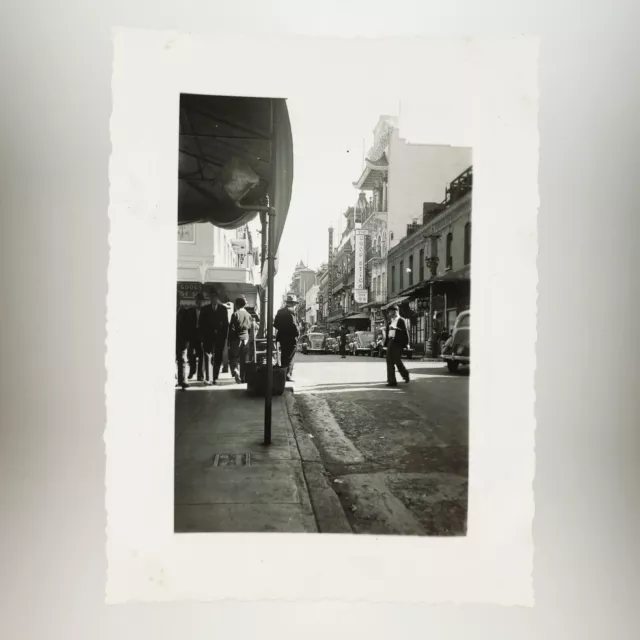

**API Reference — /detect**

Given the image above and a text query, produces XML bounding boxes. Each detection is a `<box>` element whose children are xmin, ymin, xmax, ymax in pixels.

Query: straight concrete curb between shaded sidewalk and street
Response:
<box><xmin>284</xmin><ymin>389</ymin><xmax>353</xmax><ymax>533</ymax></box>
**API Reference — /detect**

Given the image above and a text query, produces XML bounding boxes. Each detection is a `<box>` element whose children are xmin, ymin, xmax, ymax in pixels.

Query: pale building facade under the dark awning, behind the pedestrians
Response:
<box><xmin>177</xmin><ymin>223</ymin><xmax>260</xmax><ymax>306</ymax></box>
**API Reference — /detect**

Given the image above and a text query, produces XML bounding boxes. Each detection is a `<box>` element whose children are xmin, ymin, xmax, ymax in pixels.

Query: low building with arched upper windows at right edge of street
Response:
<box><xmin>387</xmin><ymin>167</ymin><xmax>473</xmax><ymax>351</ymax></box>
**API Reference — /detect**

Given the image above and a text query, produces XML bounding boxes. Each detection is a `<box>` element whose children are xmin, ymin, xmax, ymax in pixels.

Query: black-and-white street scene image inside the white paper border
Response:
<box><xmin>174</xmin><ymin>94</ymin><xmax>473</xmax><ymax>536</ymax></box>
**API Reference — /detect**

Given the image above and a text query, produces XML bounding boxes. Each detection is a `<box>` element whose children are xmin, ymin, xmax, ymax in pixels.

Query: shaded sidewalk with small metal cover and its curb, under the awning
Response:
<box><xmin>174</xmin><ymin>374</ymin><xmax>351</xmax><ymax>533</ymax></box>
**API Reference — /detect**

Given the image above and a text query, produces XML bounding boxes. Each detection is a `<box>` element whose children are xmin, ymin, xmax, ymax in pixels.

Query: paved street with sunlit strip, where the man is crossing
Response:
<box><xmin>294</xmin><ymin>354</ymin><xmax>469</xmax><ymax>535</ymax></box>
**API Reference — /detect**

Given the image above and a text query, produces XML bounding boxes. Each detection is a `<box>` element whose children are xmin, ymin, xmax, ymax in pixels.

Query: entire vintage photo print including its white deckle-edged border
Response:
<box><xmin>105</xmin><ymin>29</ymin><xmax>538</xmax><ymax>604</ymax></box>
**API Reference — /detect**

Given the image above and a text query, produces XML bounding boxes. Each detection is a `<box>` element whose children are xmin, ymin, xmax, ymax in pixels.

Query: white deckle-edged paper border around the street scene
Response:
<box><xmin>105</xmin><ymin>29</ymin><xmax>538</xmax><ymax>606</ymax></box>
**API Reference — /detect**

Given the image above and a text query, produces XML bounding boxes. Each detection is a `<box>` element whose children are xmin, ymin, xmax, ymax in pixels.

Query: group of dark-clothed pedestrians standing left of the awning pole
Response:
<box><xmin>176</xmin><ymin>288</ymin><xmax>259</xmax><ymax>390</ymax></box>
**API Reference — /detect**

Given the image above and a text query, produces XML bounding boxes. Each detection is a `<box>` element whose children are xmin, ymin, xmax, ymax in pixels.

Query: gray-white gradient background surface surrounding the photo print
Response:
<box><xmin>0</xmin><ymin>0</ymin><xmax>640</xmax><ymax>640</ymax></box>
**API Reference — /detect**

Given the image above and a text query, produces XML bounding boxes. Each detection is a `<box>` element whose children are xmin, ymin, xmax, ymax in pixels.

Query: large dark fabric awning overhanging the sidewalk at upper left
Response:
<box><xmin>178</xmin><ymin>94</ymin><xmax>293</xmax><ymax>254</ymax></box>
